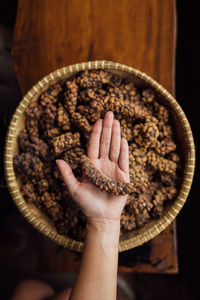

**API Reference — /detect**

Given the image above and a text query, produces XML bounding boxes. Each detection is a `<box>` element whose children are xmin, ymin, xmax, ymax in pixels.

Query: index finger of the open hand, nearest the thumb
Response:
<box><xmin>87</xmin><ymin>119</ymin><xmax>103</xmax><ymax>159</ymax></box>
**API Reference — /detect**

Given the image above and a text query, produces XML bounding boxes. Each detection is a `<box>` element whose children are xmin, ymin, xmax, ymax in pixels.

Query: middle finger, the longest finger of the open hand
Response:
<box><xmin>99</xmin><ymin>111</ymin><xmax>114</xmax><ymax>158</ymax></box>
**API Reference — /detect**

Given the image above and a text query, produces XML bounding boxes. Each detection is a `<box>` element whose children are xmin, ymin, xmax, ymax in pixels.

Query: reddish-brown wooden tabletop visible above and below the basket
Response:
<box><xmin>12</xmin><ymin>0</ymin><xmax>178</xmax><ymax>273</ymax></box>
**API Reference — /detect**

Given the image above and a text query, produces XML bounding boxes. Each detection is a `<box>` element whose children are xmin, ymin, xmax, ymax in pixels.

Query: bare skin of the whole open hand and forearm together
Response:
<box><xmin>55</xmin><ymin>112</ymin><xmax>130</xmax><ymax>300</ymax></box>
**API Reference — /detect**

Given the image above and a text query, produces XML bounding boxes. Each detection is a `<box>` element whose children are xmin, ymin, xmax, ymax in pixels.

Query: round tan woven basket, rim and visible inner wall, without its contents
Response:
<box><xmin>5</xmin><ymin>61</ymin><xmax>195</xmax><ymax>252</ymax></box>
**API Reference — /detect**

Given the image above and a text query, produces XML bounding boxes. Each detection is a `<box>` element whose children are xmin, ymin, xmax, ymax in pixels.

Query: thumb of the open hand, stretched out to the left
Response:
<box><xmin>56</xmin><ymin>159</ymin><xmax>79</xmax><ymax>198</ymax></box>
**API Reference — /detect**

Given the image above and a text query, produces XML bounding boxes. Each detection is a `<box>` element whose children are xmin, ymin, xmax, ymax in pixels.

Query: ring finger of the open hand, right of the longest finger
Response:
<box><xmin>110</xmin><ymin>120</ymin><xmax>121</xmax><ymax>162</ymax></box>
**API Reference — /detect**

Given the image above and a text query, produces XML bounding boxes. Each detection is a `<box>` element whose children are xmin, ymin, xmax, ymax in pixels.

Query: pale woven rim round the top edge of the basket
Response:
<box><xmin>4</xmin><ymin>60</ymin><xmax>195</xmax><ymax>252</ymax></box>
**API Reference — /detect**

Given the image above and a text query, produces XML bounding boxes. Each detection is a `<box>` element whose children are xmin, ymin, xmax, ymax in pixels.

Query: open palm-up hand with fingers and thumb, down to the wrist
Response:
<box><xmin>57</xmin><ymin>112</ymin><xmax>130</xmax><ymax>220</ymax></box>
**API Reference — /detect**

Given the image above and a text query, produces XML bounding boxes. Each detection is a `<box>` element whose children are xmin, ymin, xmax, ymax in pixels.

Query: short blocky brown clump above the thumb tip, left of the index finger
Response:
<box><xmin>52</xmin><ymin>132</ymin><xmax>80</xmax><ymax>155</ymax></box>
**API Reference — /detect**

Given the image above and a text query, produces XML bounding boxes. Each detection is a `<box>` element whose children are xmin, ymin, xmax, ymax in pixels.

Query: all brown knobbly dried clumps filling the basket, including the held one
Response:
<box><xmin>14</xmin><ymin>70</ymin><xmax>181</xmax><ymax>240</ymax></box>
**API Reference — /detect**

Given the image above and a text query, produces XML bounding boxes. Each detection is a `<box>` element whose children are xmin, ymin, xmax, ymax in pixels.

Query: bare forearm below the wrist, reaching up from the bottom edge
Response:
<box><xmin>70</xmin><ymin>220</ymin><xmax>120</xmax><ymax>300</ymax></box>
